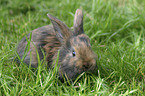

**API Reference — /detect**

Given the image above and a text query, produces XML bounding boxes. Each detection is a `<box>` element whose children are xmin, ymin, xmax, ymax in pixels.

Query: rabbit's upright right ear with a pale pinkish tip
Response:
<box><xmin>74</xmin><ymin>9</ymin><xmax>84</xmax><ymax>35</ymax></box>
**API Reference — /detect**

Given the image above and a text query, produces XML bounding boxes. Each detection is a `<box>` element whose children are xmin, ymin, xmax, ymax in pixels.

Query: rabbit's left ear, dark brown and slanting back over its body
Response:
<box><xmin>47</xmin><ymin>14</ymin><xmax>72</xmax><ymax>41</ymax></box>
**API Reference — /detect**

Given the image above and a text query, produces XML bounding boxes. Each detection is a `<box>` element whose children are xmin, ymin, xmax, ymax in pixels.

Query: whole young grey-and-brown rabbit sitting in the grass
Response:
<box><xmin>17</xmin><ymin>9</ymin><xmax>97</xmax><ymax>80</ymax></box>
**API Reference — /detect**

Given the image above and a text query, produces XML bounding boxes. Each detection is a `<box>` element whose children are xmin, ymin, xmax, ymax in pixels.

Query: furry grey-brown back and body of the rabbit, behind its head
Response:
<box><xmin>17</xmin><ymin>25</ymin><xmax>61</xmax><ymax>67</ymax></box>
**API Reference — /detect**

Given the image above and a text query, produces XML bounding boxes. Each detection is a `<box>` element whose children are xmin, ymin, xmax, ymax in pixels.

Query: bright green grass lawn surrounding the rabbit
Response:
<box><xmin>0</xmin><ymin>0</ymin><xmax>145</xmax><ymax>96</ymax></box>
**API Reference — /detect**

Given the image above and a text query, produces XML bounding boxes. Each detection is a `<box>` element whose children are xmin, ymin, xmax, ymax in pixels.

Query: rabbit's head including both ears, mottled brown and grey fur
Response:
<box><xmin>48</xmin><ymin>9</ymin><xmax>97</xmax><ymax>79</ymax></box>
